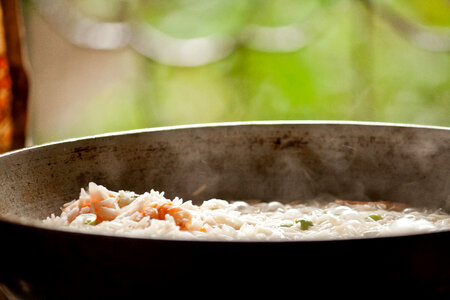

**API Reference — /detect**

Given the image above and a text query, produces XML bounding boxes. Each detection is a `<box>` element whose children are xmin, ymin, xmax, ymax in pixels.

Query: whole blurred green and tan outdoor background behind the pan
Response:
<box><xmin>21</xmin><ymin>0</ymin><xmax>450</xmax><ymax>144</ymax></box>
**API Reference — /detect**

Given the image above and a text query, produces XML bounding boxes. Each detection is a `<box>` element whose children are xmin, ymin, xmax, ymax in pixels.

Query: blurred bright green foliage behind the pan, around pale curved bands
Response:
<box><xmin>32</xmin><ymin>0</ymin><xmax>450</xmax><ymax>142</ymax></box>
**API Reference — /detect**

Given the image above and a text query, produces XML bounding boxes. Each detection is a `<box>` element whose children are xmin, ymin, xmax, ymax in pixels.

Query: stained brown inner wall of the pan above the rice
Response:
<box><xmin>0</xmin><ymin>124</ymin><xmax>450</xmax><ymax>219</ymax></box>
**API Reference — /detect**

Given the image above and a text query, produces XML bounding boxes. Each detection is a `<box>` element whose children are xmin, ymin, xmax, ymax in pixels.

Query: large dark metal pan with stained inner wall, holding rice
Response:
<box><xmin>0</xmin><ymin>122</ymin><xmax>450</xmax><ymax>299</ymax></box>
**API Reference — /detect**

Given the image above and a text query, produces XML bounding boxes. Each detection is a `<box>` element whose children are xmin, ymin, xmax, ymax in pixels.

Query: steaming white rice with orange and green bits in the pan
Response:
<box><xmin>43</xmin><ymin>183</ymin><xmax>450</xmax><ymax>240</ymax></box>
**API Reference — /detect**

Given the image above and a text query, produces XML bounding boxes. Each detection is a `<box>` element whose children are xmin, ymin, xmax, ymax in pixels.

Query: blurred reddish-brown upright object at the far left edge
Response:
<box><xmin>0</xmin><ymin>0</ymin><xmax>28</xmax><ymax>153</ymax></box>
